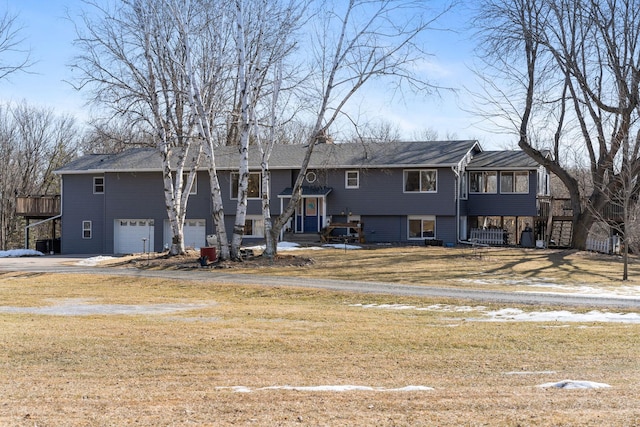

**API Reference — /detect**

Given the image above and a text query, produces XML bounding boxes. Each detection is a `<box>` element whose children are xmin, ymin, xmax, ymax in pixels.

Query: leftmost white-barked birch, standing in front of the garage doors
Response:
<box><xmin>75</xmin><ymin>0</ymin><xmax>202</xmax><ymax>255</ymax></box>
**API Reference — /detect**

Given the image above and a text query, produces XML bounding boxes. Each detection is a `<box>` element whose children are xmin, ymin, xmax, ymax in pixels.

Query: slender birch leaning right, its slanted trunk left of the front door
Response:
<box><xmin>265</xmin><ymin>0</ymin><xmax>452</xmax><ymax>256</ymax></box>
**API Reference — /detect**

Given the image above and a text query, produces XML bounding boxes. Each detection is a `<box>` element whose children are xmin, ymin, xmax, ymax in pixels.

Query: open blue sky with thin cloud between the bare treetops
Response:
<box><xmin>0</xmin><ymin>0</ymin><xmax>512</xmax><ymax>149</ymax></box>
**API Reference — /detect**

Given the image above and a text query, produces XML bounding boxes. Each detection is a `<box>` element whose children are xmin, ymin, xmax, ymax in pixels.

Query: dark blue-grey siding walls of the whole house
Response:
<box><xmin>61</xmin><ymin>163</ymin><xmax>537</xmax><ymax>254</ymax></box>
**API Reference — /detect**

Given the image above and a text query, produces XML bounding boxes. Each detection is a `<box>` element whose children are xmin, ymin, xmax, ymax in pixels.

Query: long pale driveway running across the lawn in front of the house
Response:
<box><xmin>0</xmin><ymin>255</ymin><xmax>640</xmax><ymax>310</ymax></box>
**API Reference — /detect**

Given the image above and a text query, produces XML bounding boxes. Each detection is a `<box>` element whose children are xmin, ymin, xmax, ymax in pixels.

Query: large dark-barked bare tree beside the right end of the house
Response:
<box><xmin>476</xmin><ymin>0</ymin><xmax>640</xmax><ymax>249</ymax></box>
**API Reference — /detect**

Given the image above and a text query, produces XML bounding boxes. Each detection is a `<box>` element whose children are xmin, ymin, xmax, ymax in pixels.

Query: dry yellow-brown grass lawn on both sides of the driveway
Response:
<box><xmin>0</xmin><ymin>248</ymin><xmax>640</xmax><ymax>426</ymax></box>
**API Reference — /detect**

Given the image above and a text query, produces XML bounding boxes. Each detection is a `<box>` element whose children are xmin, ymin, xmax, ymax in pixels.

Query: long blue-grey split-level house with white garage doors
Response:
<box><xmin>56</xmin><ymin>140</ymin><xmax>548</xmax><ymax>254</ymax></box>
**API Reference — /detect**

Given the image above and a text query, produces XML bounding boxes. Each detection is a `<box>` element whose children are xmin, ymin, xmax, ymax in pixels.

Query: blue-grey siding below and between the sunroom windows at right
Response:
<box><xmin>461</xmin><ymin>171</ymin><xmax>538</xmax><ymax>216</ymax></box>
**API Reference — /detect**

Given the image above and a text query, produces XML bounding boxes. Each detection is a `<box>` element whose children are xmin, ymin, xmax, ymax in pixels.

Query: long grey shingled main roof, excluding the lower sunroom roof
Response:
<box><xmin>56</xmin><ymin>140</ymin><xmax>481</xmax><ymax>175</ymax></box>
